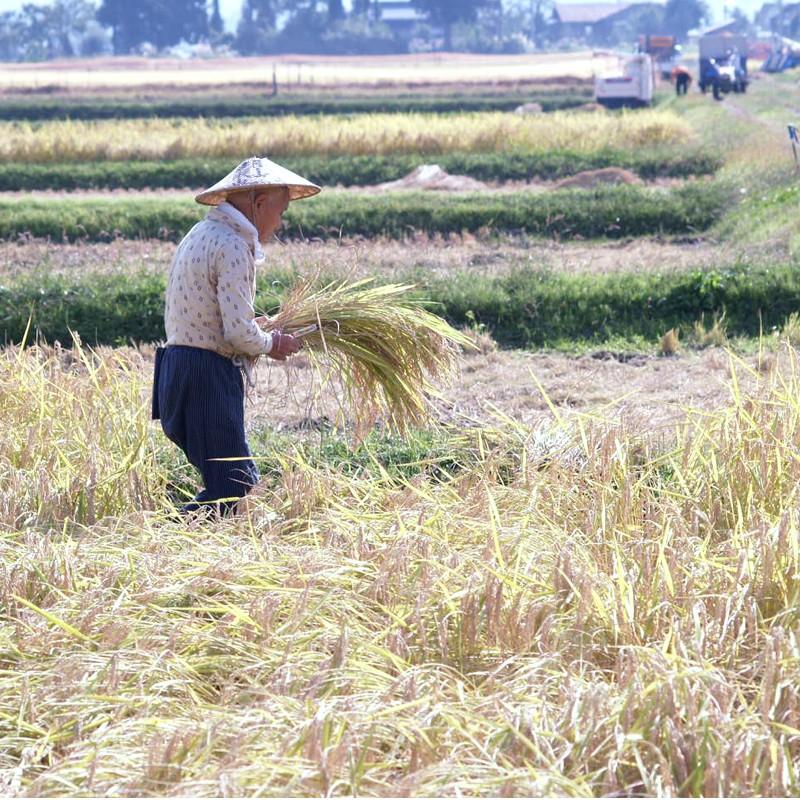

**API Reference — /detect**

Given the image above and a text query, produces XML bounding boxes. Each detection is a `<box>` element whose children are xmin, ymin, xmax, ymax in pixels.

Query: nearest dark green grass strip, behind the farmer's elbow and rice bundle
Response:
<box><xmin>0</xmin><ymin>264</ymin><xmax>800</xmax><ymax>348</ymax></box>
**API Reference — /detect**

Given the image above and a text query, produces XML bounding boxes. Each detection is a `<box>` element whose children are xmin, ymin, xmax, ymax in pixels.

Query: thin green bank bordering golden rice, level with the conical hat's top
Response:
<box><xmin>0</xmin><ymin>147</ymin><xmax>722</xmax><ymax>192</ymax></box>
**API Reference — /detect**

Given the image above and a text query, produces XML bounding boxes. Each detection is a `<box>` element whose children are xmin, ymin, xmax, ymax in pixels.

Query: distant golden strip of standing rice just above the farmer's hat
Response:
<box><xmin>0</xmin><ymin>110</ymin><xmax>697</xmax><ymax>163</ymax></box>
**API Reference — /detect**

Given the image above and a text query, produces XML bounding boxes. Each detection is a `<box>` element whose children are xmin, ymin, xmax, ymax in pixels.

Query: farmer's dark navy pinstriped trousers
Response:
<box><xmin>153</xmin><ymin>345</ymin><xmax>259</xmax><ymax>515</ymax></box>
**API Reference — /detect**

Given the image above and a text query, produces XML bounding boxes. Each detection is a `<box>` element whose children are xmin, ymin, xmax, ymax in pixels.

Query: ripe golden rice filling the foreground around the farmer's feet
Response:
<box><xmin>0</xmin><ymin>342</ymin><xmax>800</xmax><ymax>796</ymax></box>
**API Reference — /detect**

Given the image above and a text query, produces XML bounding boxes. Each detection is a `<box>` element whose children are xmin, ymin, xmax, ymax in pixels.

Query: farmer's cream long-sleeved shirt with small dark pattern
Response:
<box><xmin>164</xmin><ymin>203</ymin><xmax>272</xmax><ymax>358</ymax></box>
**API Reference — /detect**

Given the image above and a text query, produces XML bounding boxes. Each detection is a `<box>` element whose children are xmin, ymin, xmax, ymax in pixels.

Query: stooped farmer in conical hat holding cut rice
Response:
<box><xmin>153</xmin><ymin>158</ymin><xmax>320</xmax><ymax>516</ymax></box>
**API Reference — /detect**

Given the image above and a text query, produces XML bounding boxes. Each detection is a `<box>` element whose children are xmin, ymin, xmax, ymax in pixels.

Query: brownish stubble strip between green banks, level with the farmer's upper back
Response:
<box><xmin>0</xmin><ymin>236</ymin><xmax>764</xmax><ymax>280</ymax></box>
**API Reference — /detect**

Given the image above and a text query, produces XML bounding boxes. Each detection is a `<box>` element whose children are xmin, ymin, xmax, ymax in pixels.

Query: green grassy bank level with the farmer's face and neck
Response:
<box><xmin>0</xmin><ymin>182</ymin><xmax>732</xmax><ymax>241</ymax></box>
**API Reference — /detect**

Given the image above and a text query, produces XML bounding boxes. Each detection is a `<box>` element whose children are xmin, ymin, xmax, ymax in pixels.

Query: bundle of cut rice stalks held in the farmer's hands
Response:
<box><xmin>269</xmin><ymin>279</ymin><xmax>472</xmax><ymax>434</ymax></box>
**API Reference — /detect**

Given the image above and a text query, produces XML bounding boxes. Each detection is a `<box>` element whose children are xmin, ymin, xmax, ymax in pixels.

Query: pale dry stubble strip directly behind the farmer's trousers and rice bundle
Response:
<box><xmin>119</xmin><ymin>348</ymin><xmax>778</xmax><ymax>433</ymax></box>
